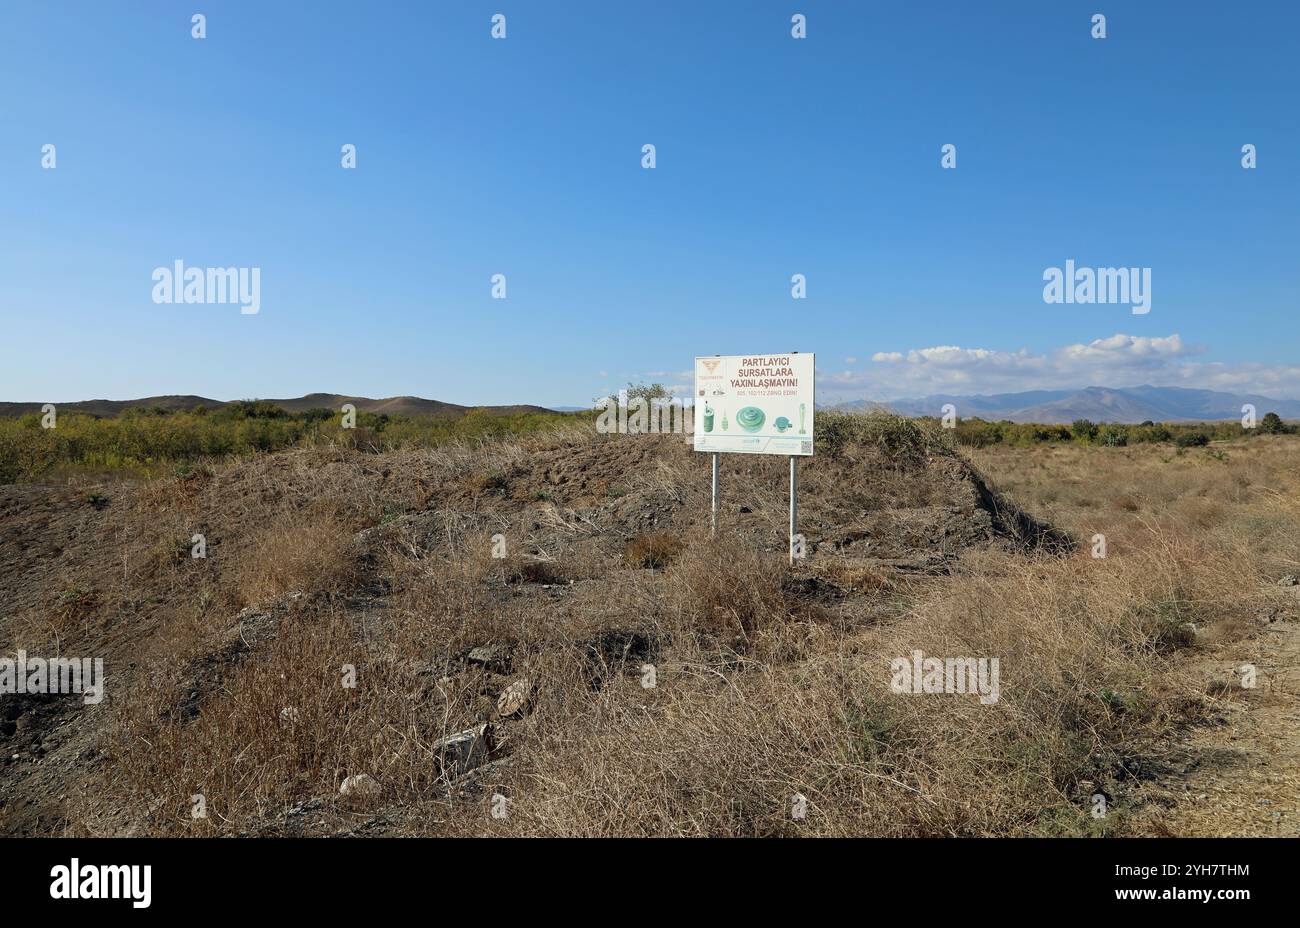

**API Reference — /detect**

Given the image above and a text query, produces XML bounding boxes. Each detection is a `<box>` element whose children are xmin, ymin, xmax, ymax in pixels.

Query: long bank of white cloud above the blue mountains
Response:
<box><xmin>819</xmin><ymin>333</ymin><xmax>1300</xmax><ymax>402</ymax></box>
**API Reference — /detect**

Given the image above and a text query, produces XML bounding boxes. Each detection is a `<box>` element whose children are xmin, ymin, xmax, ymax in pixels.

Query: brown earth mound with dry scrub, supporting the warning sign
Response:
<box><xmin>0</xmin><ymin>423</ymin><xmax>1074</xmax><ymax>834</ymax></box>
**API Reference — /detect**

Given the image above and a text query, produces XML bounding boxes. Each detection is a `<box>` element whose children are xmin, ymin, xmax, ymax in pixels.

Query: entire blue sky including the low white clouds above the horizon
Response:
<box><xmin>0</xmin><ymin>0</ymin><xmax>1300</xmax><ymax>404</ymax></box>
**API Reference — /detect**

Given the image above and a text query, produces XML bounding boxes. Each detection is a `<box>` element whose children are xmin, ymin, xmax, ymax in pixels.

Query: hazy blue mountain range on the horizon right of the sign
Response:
<box><xmin>833</xmin><ymin>385</ymin><xmax>1300</xmax><ymax>424</ymax></box>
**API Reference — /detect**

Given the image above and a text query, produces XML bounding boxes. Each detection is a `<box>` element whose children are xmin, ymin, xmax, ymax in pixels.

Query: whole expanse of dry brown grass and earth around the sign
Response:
<box><xmin>0</xmin><ymin>417</ymin><xmax>1300</xmax><ymax>836</ymax></box>
